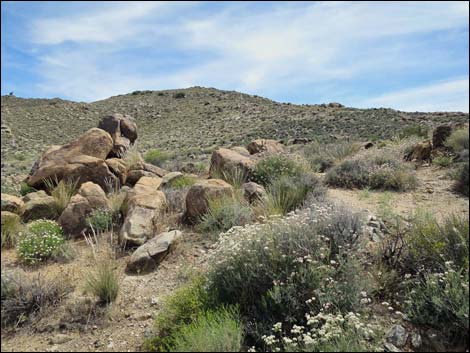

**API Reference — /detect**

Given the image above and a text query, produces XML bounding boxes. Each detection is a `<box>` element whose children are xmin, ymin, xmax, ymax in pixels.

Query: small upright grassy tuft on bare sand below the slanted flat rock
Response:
<box><xmin>85</xmin><ymin>261</ymin><xmax>119</xmax><ymax>304</ymax></box>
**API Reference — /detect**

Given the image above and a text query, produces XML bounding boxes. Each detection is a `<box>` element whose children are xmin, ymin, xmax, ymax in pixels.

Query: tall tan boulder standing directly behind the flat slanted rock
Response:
<box><xmin>119</xmin><ymin>176</ymin><xmax>166</xmax><ymax>245</ymax></box>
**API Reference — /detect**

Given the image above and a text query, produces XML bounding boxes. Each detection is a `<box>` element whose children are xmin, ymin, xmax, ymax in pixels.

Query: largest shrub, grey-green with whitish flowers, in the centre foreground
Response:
<box><xmin>208</xmin><ymin>205</ymin><xmax>363</xmax><ymax>345</ymax></box>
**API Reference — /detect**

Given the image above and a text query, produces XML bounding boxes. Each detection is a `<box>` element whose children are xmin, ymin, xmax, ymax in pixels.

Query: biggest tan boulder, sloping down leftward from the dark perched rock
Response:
<box><xmin>26</xmin><ymin>128</ymin><xmax>119</xmax><ymax>189</ymax></box>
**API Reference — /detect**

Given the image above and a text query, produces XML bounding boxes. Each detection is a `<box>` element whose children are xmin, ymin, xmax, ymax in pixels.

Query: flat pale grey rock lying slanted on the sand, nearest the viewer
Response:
<box><xmin>127</xmin><ymin>230</ymin><xmax>182</xmax><ymax>273</ymax></box>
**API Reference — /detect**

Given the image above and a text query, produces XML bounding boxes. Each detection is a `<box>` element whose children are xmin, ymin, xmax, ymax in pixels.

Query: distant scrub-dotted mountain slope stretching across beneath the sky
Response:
<box><xmin>1</xmin><ymin>87</ymin><xmax>468</xmax><ymax>160</ymax></box>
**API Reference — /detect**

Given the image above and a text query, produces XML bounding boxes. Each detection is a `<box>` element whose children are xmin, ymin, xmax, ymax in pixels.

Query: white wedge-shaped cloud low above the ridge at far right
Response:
<box><xmin>360</xmin><ymin>78</ymin><xmax>469</xmax><ymax>112</ymax></box>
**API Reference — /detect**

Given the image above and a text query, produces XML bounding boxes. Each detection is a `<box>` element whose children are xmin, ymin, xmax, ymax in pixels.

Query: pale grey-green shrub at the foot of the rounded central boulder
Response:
<box><xmin>198</xmin><ymin>196</ymin><xmax>253</xmax><ymax>233</ymax></box>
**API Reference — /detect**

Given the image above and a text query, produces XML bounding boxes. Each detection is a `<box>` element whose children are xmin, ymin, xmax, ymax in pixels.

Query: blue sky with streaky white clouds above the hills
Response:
<box><xmin>1</xmin><ymin>1</ymin><xmax>469</xmax><ymax>112</ymax></box>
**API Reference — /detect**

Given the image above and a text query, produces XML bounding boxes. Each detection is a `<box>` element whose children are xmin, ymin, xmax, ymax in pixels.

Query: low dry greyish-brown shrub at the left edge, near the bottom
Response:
<box><xmin>1</xmin><ymin>273</ymin><xmax>73</xmax><ymax>326</ymax></box>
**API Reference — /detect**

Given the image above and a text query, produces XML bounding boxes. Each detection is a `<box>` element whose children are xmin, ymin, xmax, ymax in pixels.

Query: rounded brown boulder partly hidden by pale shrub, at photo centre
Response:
<box><xmin>184</xmin><ymin>179</ymin><xmax>234</xmax><ymax>223</ymax></box>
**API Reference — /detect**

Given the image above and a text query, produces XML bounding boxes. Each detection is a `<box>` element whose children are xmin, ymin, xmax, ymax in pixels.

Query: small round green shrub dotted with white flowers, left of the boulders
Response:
<box><xmin>17</xmin><ymin>219</ymin><xmax>64</xmax><ymax>265</ymax></box>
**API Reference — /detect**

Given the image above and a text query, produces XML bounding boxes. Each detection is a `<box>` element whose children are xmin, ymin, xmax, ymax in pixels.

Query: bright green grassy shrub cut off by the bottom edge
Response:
<box><xmin>171</xmin><ymin>307</ymin><xmax>243</xmax><ymax>352</ymax></box>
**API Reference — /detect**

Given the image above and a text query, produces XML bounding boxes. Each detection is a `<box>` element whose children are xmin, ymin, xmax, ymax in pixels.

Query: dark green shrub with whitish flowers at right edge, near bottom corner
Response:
<box><xmin>406</xmin><ymin>263</ymin><xmax>469</xmax><ymax>343</ymax></box>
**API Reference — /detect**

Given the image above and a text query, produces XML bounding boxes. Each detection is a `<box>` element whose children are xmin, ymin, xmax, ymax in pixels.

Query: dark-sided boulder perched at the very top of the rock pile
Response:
<box><xmin>98</xmin><ymin>114</ymin><xmax>137</xmax><ymax>158</ymax></box>
